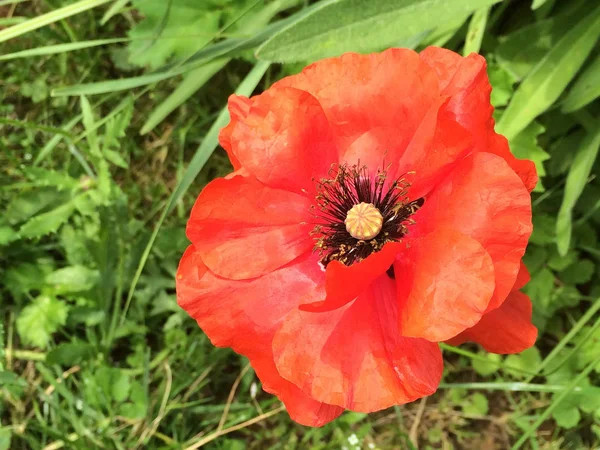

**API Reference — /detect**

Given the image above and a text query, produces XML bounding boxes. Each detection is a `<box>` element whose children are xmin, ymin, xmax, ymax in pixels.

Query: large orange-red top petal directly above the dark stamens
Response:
<box><xmin>274</xmin><ymin>48</ymin><xmax>439</xmax><ymax>166</ymax></box>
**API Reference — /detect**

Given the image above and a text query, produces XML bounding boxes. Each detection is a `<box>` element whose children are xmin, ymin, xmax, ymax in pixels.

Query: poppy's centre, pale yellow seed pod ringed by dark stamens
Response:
<box><xmin>311</xmin><ymin>164</ymin><xmax>425</xmax><ymax>266</ymax></box>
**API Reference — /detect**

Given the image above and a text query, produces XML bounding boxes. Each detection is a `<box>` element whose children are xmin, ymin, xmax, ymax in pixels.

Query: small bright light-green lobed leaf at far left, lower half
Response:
<box><xmin>17</xmin><ymin>295</ymin><xmax>69</xmax><ymax>348</ymax></box>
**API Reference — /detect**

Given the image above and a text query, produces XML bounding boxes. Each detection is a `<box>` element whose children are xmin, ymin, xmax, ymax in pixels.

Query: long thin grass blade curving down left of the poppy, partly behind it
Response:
<box><xmin>121</xmin><ymin>62</ymin><xmax>270</xmax><ymax>325</ymax></box>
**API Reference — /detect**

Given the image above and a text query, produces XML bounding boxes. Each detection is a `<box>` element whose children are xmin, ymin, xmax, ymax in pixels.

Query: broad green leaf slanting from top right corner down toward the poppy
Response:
<box><xmin>496</xmin><ymin>6</ymin><xmax>600</xmax><ymax>140</ymax></box>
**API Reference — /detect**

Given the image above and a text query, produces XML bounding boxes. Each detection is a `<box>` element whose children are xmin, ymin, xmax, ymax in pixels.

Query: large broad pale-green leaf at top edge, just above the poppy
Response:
<box><xmin>256</xmin><ymin>0</ymin><xmax>497</xmax><ymax>62</ymax></box>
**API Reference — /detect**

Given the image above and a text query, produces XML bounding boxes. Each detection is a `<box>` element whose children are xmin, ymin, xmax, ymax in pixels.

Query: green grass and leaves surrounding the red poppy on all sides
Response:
<box><xmin>0</xmin><ymin>0</ymin><xmax>600</xmax><ymax>450</ymax></box>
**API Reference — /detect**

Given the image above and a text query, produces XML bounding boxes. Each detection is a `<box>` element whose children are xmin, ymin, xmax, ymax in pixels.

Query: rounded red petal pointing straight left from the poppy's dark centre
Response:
<box><xmin>187</xmin><ymin>176</ymin><xmax>313</xmax><ymax>280</ymax></box>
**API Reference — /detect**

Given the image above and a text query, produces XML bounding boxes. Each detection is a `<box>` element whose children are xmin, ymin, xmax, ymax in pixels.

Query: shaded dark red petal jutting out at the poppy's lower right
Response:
<box><xmin>448</xmin><ymin>291</ymin><xmax>537</xmax><ymax>354</ymax></box>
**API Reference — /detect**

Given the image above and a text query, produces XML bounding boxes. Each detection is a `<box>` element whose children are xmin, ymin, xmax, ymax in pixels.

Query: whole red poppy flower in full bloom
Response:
<box><xmin>177</xmin><ymin>47</ymin><xmax>537</xmax><ymax>426</ymax></box>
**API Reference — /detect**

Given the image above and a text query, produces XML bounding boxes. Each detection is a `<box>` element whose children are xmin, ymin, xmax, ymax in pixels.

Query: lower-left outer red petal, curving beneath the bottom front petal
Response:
<box><xmin>177</xmin><ymin>245</ymin><xmax>343</xmax><ymax>426</ymax></box>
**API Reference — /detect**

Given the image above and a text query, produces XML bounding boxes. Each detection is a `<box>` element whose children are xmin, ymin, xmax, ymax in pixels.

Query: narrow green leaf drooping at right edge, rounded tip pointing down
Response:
<box><xmin>556</xmin><ymin>127</ymin><xmax>600</xmax><ymax>255</ymax></box>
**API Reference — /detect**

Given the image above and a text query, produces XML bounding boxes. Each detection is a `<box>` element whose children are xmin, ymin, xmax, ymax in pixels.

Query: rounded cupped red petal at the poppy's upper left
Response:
<box><xmin>229</xmin><ymin>87</ymin><xmax>337</xmax><ymax>192</ymax></box>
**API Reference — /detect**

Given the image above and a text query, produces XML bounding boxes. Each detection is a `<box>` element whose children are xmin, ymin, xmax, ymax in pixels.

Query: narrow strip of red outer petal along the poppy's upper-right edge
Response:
<box><xmin>419</xmin><ymin>47</ymin><xmax>537</xmax><ymax>192</ymax></box>
